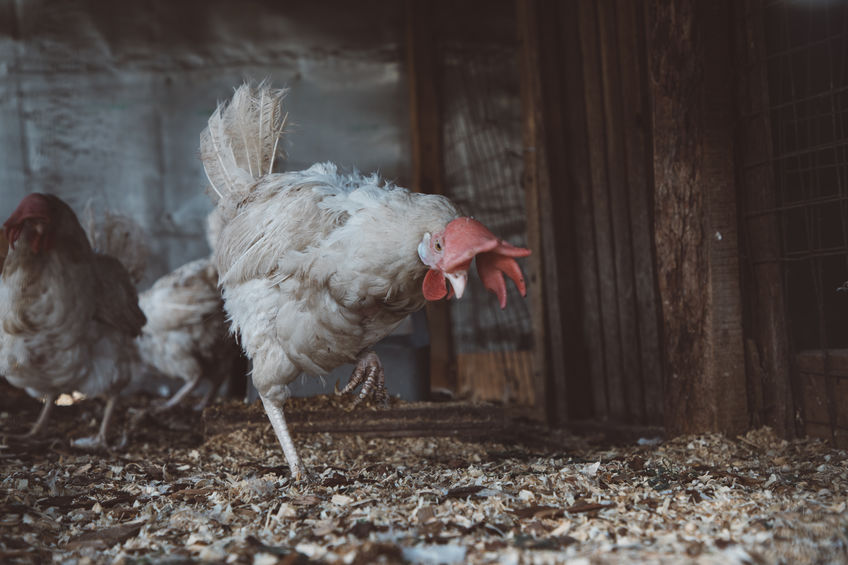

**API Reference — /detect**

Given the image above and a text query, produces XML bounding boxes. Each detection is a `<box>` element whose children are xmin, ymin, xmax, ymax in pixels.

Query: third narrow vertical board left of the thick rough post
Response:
<box><xmin>578</xmin><ymin>0</ymin><xmax>627</xmax><ymax>421</ymax></box>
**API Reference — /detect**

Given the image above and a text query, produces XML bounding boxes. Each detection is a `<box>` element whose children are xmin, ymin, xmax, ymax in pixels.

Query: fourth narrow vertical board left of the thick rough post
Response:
<box><xmin>554</xmin><ymin>2</ymin><xmax>610</xmax><ymax>421</ymax></box>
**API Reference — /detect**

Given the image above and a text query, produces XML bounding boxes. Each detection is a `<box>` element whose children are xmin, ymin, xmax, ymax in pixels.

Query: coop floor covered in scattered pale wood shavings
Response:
<box><xmin>0</xmin><ymin>390</ymin><xmax>848</xmax><ymax>564</ymax></box>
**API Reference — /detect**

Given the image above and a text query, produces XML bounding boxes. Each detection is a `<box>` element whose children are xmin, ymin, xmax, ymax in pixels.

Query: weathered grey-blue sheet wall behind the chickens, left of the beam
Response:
<box><xmin>0</xmin><ymin>0</ymin><xmax>409</xmax><ymax>282</ymax></box>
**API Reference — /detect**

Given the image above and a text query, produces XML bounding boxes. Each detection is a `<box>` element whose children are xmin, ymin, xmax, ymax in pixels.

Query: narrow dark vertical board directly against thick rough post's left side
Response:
<box><xmin>615</xmin><ymin>0</ymin><xmax>663</xmax><ymax>425</ymax></box>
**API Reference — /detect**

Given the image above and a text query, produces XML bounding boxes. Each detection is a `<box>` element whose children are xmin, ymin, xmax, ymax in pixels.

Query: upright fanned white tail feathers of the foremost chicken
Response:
<box><xmin>200</xmin><ymin>82</ymin><xmax>288</xmax><ymax>215</ymax></box>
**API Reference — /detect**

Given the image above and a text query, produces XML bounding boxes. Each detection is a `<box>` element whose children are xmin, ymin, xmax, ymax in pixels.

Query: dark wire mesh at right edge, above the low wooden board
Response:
<box><xmin>764</xmin><ymin>2</ymin><xmax>848</xmax><ymax>350</ymax></box>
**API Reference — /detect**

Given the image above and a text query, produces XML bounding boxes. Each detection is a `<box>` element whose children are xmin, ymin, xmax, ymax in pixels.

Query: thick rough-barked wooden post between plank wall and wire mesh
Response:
<box><xmin>646</xmin><ymin>0</ymin><xmax>748</xmax><ymax>435</ymax></box>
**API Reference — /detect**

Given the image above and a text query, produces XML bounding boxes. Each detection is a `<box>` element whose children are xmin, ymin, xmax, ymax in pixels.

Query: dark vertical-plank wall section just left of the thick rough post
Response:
<box><xmin>518</xmin><ymin>0</ymin><xmax>663</xmax><ymax>425</ymax></box>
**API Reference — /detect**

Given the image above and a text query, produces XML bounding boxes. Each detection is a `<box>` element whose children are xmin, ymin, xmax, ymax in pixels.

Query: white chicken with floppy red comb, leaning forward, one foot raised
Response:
<box><xmin>201</xmin><ymin>84</ymin><xmax>530</xmax><ymax>476</ymax></box>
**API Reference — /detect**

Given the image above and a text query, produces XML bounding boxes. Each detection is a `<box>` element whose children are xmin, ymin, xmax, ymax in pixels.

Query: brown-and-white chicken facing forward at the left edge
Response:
<box><xmin>0</xmin><ymin>194</ymin><xmax>145</xmax><ymax>446</ymax></box>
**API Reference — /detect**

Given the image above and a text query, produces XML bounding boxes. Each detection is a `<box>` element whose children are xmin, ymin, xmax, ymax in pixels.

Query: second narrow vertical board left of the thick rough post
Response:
<box><xmin>596</xmin><ymin>0</ymin><xmax>645</xmax><ymax>423</ymax></box>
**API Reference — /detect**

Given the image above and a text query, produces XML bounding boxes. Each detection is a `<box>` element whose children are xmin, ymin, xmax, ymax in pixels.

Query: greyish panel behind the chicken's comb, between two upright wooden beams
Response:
<box><xmin>435</xmin><ymin>2</ymin><xmax>533</xmax><ymax>405</ymax></box>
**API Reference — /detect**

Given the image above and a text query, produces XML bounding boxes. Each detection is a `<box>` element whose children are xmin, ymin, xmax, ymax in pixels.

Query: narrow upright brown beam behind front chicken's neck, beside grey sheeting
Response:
<box><xmin>406</xmin><ymin>0</ymin><xmax>457</xmax><ymax>391</ymax></box>
